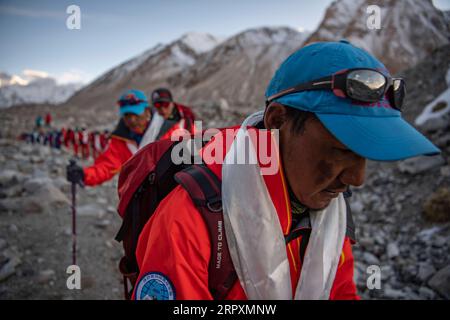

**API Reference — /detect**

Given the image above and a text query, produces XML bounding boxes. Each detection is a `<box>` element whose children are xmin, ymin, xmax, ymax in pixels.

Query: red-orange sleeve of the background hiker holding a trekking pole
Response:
<box><xmin>84</xmin><ymin>137</ymin><xmax>132</xmax><ymax>186</ymax></box>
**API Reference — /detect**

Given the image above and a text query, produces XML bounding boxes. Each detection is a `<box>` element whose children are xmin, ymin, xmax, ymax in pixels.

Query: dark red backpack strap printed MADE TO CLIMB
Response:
<box><xmin>175</xmin><ymin>165</ymin><xmax>237</xmax><ymax>300</ymax></box>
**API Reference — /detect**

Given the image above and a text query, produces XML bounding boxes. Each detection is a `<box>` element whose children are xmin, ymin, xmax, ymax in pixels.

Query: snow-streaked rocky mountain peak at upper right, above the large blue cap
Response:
<box><xmin>306</xmin><ymin>0</ymin><xmax>450</xmax><ymax>73</ymax></box>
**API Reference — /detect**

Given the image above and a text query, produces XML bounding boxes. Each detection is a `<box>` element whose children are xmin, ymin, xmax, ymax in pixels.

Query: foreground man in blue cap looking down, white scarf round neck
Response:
<box><xmin>134</xmin><ymin>41</ymin><xmax>439</xmax><ymax>300</ymax></box>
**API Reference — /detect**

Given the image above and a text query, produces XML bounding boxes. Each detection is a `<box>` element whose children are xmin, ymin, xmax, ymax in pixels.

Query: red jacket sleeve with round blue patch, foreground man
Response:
<box><xmin>133</xmin><ymin>186</ymin><xmax>212</xmax><ymax>300</ymax></box>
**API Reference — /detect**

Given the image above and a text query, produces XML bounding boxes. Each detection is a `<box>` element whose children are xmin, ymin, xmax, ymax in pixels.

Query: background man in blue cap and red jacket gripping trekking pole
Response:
<box><xmin>67</xmin><ymin>90</ymin><xmax>164</xmax><ymax>186</ymax></box>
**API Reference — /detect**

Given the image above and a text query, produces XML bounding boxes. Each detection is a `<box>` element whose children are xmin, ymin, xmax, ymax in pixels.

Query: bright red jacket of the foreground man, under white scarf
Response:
<box><xmin>133</xmin><ymin>126</ymin><xmax>359</xmax><ymax>300</ymax></box>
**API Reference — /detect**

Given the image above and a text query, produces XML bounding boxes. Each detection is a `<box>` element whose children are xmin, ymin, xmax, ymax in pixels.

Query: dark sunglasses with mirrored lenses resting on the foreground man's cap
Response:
<box><xmin>266</xmin><ymin>68</ymin><xmax>406</xmax><ymax>111</ymax></box>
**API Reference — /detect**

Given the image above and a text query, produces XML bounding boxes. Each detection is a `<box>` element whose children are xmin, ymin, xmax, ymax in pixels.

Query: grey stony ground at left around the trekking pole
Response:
<box><xmin>0</xmin><ymin>140</ymin><xmax>123</xmax><ymax>299</ymax></box>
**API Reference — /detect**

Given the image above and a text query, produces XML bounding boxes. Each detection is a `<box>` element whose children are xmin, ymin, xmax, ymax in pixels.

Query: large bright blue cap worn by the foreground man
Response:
<box><xmin>266</xmin><ymin>40</ymin><xmax>440</xmax><ymax>161</ymax></box>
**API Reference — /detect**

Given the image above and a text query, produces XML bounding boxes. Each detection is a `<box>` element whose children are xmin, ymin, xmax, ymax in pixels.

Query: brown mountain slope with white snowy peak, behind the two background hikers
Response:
<box><xmin>67</xmin><ymin>33</ymin><xmax>221</xmax><ymax>113</ymax></box>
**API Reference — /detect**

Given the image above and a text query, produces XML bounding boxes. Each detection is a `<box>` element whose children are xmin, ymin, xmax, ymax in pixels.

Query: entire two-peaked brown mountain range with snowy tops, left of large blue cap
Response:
<box><xmin>66</xmin><ymin>27</ymin><xmax>308</xmax><ymax>120</ymax></box>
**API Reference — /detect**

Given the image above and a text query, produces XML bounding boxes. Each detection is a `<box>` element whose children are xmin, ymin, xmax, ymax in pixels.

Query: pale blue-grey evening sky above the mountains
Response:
<box><xmin>0</xmin><ymin>0</ymin><xmax>450</xmax><ymax>83</ymax></box>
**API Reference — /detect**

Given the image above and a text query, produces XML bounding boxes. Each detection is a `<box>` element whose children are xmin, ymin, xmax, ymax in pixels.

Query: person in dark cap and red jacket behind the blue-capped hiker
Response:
<box><xmin>151</xmin><ymin>88</ymin><xmax>195</xmax><ymax>140</ymax></box>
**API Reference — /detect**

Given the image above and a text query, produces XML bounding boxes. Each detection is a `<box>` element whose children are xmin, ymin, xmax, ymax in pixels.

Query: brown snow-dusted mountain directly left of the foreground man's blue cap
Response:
<box><xmin>169</xmin><ymin>27</ymin><xmax>309</xmax><ymax>107</ymax></box>
